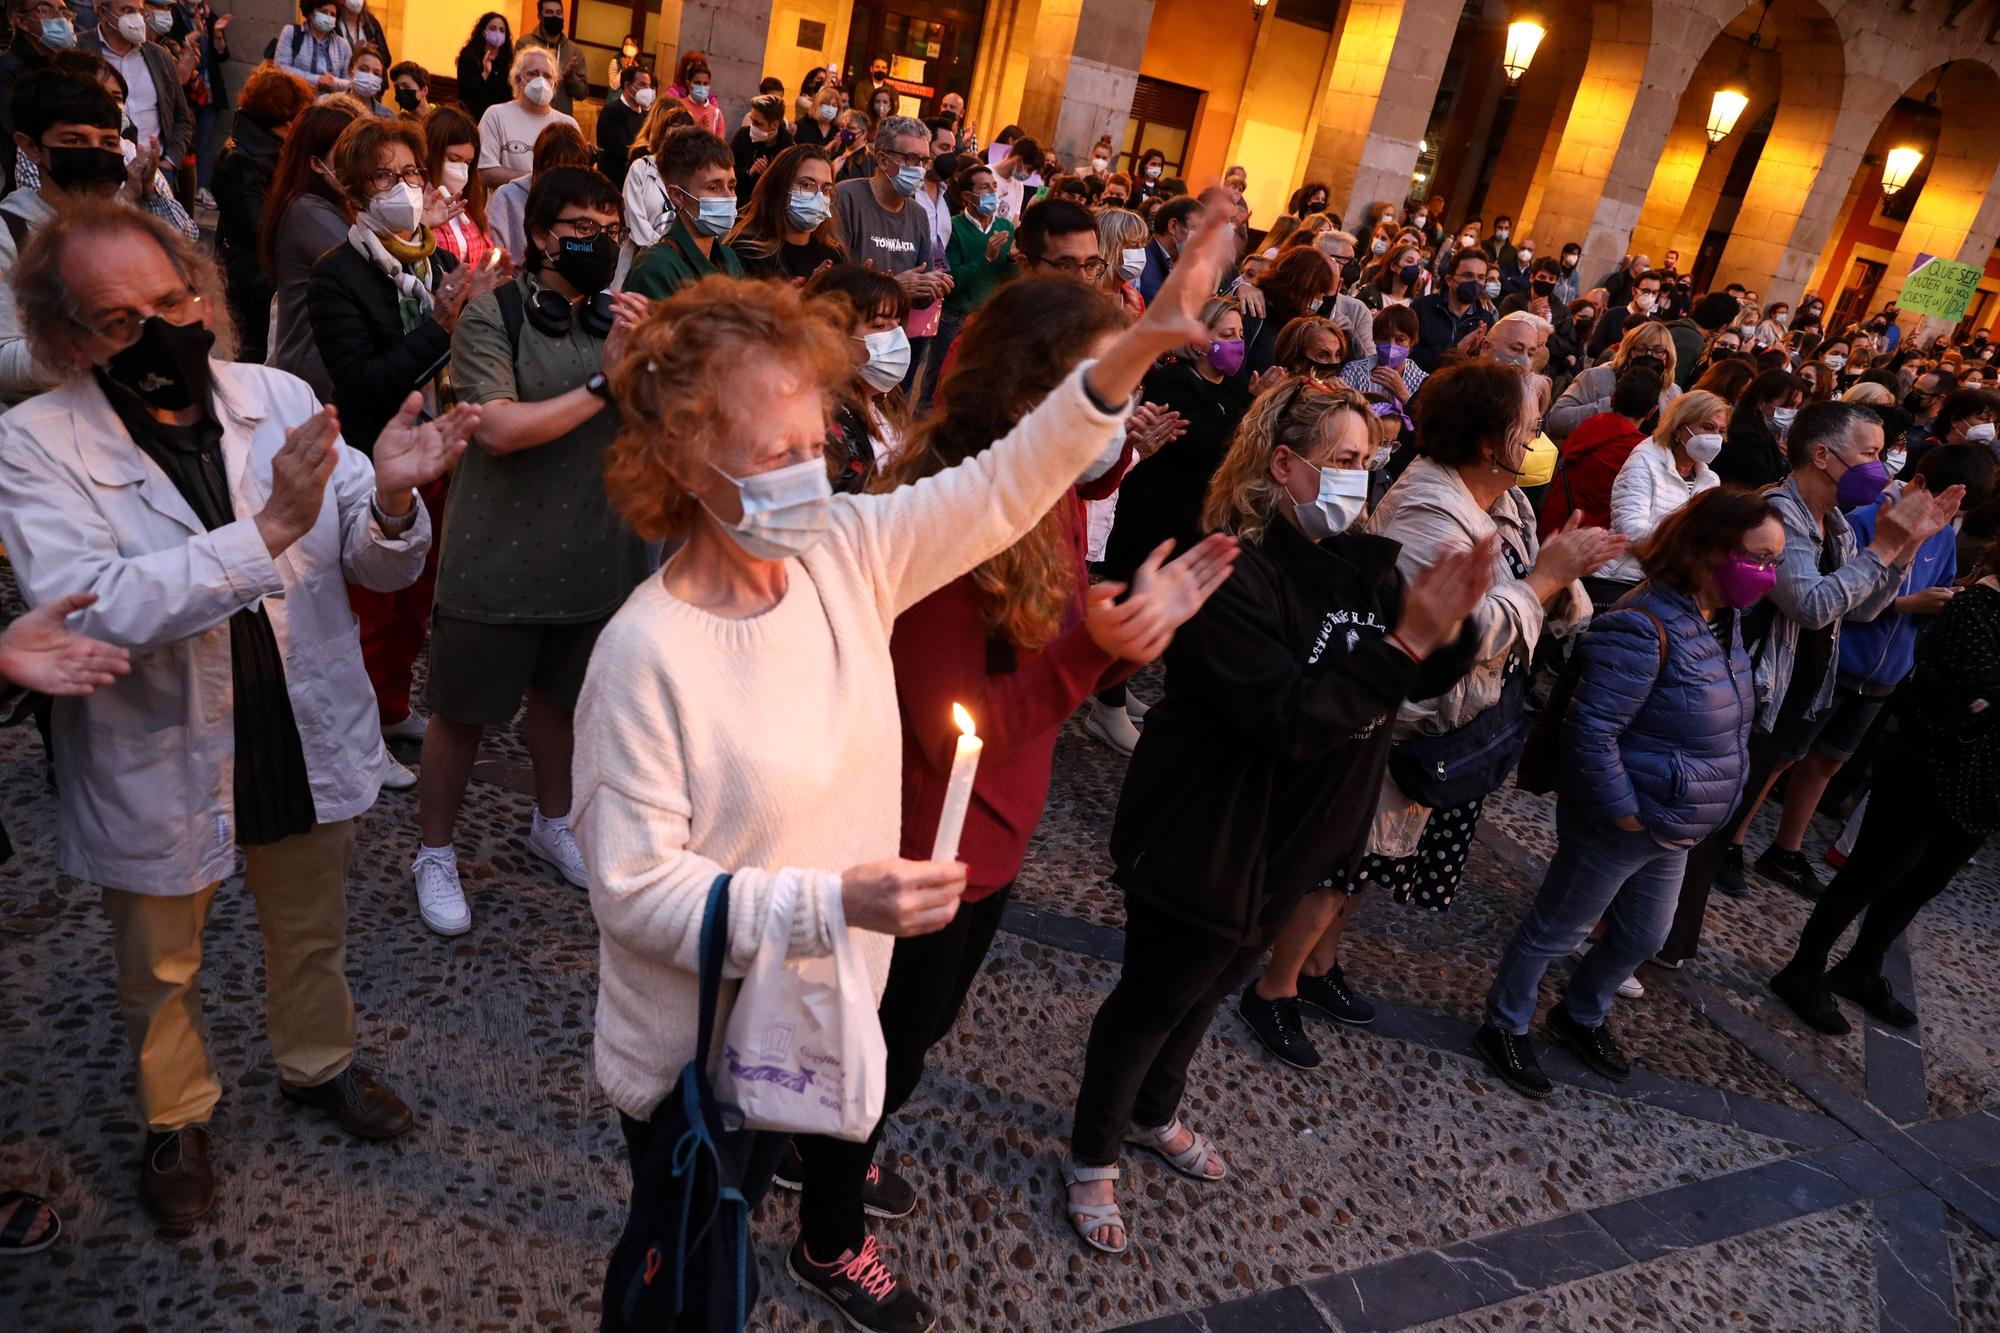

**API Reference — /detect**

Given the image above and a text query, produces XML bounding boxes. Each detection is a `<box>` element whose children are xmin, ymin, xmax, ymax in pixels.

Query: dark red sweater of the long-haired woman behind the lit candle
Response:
<box><xmin>888</xmin><ymin>492</ymin><xmax>1136</xmax><ymax>903</ymax></box>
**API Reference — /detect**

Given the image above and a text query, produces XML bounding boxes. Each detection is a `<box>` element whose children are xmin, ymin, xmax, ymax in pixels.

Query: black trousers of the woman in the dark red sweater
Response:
<box><xmin>794</xmin><ymin>885</ymin><xmax>1012</xmax><ymax>1263</ymax></box>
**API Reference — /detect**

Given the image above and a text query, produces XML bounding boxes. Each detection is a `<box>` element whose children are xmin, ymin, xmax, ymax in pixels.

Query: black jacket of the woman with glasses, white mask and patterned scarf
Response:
<box><xmin>306</xmin><ymin>244</ymin><xmax>458</xmax><ymax>454</ymax></box>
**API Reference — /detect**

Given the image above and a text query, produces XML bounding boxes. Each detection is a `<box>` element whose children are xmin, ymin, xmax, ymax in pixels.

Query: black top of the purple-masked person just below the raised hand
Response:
<box><xmin>1104</xmin><ymin>360</ymin><xmax>1250</xmax><ymax>578</ymax></box>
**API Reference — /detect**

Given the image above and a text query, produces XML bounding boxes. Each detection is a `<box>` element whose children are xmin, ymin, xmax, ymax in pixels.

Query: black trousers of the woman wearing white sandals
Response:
<box><xmin>1070</xmin><ymin>899</ymin><xmax>1282</xmax><ymax>1167</ymax></box>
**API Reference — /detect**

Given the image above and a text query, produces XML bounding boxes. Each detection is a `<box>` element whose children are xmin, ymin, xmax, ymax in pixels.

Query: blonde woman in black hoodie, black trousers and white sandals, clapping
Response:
<box><xmin>1064</xmin><ymin>374</ymin><xmax>1492</xmax><ymax>1255</ymax></box>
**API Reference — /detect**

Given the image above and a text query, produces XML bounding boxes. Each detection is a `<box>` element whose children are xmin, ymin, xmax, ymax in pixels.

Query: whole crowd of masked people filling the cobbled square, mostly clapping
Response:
<box><xmin>0</xmin><ymin>0</ymin><xmax>2000</xmax><ymax>1333</ymax></box>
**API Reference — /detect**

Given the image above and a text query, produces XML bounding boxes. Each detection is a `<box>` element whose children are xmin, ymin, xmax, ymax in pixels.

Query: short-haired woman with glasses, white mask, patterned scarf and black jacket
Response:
<box><xmin>306</xmin><ymin>116</ymin><xmax>510</xmax><ymax>768</ymax></box>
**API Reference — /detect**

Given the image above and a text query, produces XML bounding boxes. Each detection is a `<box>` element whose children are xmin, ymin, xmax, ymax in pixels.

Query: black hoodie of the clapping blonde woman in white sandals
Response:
<box><xmin>1112</xmin><ymin>518</ymin><xmax>1474</xmax><ymax>943</ymax></box>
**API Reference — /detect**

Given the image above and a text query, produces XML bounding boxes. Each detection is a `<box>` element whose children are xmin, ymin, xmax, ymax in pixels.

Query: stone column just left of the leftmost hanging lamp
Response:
<box><xmin>1266</xmin><ymin>0</ymin><xmax>1466</xmax><ymax>218</ymax></box>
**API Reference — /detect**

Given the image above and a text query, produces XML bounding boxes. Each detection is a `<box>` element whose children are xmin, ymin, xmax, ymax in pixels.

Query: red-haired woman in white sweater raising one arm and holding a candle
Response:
<box><xmin>572</xmin><ymin>218</ymin><xmax>1234</xmax><ymax>1305</ymax></box>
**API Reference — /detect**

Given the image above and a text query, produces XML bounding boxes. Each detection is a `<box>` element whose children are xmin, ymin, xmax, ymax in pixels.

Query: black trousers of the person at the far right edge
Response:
<box><xmin>1786</xmin><ymin>765</ymin><xmax>1986</xmax><ymax>977</ymax></box>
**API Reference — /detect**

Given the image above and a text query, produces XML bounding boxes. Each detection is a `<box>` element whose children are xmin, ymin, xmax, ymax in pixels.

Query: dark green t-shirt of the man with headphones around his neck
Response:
<box><xmin>438</xmin><ymin>274</ymin><xmax>650</xmax><ymax>624</ymax></box>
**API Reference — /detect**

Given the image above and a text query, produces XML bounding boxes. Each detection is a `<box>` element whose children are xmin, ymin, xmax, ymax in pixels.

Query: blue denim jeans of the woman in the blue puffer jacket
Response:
<box><xmin>1486</xmin><ymin>805</ymin><xmax>1688</xmax><ymax>1035</ymax></box>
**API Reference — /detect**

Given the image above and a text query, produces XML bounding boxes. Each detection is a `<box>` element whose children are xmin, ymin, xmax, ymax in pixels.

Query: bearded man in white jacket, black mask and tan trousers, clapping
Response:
<box><xmin>0</xmin><ymin>196</ymin><xmax>478</xmax><ymax>1225</ymax></box>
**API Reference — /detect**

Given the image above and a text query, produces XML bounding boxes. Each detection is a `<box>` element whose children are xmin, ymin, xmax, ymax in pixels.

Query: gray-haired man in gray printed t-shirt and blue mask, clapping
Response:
<box><xmin>834</xmin><ymin>116</ymin><xmax>952</xmax><ymax>384</ymax></box>
